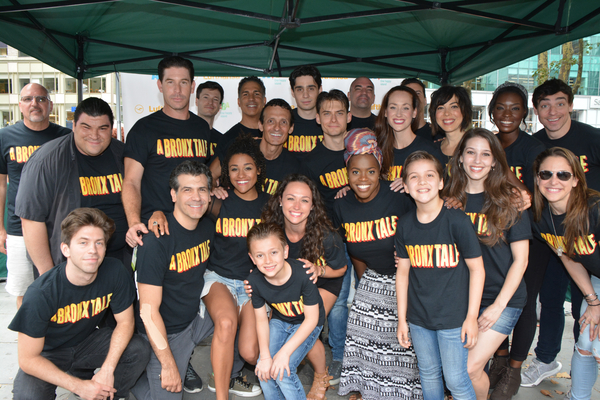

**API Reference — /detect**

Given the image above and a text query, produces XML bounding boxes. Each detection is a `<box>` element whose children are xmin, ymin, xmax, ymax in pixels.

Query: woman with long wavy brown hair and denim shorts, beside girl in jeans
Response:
<box><xmin>443</xmin><ymin>128</ymin><xmax>531</xmax><ymax>400</ymax></box>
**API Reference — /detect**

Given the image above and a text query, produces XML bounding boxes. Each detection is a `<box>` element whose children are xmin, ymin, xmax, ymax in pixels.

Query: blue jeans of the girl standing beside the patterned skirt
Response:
<box><xmin>409</xmin><ymin>323</ymin><xmax>475</xmax><ymax>400</ymax></box>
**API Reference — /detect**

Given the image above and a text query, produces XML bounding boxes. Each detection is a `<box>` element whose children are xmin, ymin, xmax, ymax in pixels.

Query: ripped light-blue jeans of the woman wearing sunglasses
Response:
<box><xmin>571</xmin><ymin>276</ymin><xmax>600</xmax><ymax>400</ymax></box>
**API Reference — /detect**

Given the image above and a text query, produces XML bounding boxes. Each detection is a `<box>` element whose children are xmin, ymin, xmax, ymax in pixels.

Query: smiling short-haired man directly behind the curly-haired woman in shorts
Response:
<box><xmin>258</xmin><ymin>99</ymin><xmax>300</xmax><ymax>195</ymax></box>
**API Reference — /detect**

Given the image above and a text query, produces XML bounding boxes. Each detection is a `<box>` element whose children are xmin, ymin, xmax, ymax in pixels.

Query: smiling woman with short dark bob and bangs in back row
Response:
<box><xmin>429</xmin><ymin>85</ymin><xmax>473</xmax><ymax>168</ymax></box>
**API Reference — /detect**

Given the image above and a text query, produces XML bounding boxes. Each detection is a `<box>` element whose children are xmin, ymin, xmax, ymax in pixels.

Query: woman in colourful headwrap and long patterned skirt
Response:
<box><xmin>334</xmin><ymin>129</ymin><xmax>423</xmax><ymax>399</ymax></box>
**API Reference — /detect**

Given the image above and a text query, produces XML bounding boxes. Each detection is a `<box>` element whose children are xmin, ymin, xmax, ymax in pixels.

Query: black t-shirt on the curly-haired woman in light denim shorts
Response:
<box><xmin>208</xmin><ymin>190</ymin><xmax>270</xmax><ymax>280</ymax></box>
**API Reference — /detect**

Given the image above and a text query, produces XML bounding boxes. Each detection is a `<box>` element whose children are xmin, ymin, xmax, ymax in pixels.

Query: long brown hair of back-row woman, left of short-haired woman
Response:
<box><xmin>375</xmin><ymin>86</ymin><xmax>420</xmax><ymax>175</ymax></box>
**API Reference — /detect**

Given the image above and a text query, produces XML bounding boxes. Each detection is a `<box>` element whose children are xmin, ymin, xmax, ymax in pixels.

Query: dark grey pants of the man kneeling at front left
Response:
<box><xmin>13</xmin><ymin>328</ymin><xmax>151</xmax><ymax>400</ymax></box>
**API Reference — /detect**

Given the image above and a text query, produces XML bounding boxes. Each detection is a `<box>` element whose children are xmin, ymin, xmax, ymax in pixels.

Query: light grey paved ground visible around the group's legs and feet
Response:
<box><xmin>0</xmin><ymin>283</ymin><xmax>600</xmax><ymax>400</ymax></box>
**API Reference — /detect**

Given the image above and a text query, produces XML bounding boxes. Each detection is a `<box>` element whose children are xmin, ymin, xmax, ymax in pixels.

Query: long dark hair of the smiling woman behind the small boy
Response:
<box><xmin>261</xmin><ymin>174</ymin><xmax>335</xmax><ymax>263</ymax></box>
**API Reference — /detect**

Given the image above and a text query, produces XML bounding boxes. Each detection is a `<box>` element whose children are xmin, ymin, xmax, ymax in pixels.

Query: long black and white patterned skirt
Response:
<box><xmin>339</xmin><ymin>269</ymin><xmax>423</xmax><ymax>400</ymax></box>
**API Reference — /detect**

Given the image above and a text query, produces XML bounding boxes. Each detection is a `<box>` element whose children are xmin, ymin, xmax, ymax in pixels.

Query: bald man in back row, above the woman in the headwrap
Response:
<box><xmin>348</xmin><ymin>76</ymin><xmax>376</xmax><ymax>130</ymax></box>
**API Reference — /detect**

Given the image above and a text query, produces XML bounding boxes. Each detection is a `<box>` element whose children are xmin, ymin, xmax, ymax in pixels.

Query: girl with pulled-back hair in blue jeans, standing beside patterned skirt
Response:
<box><xmin>395</xmin><ymin>151</ymin><xmax>485</xmax><ymax>399</ymax></box>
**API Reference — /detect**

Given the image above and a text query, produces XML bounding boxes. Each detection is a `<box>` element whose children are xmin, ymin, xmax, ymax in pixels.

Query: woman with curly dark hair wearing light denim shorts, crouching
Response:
<box><xmin>201</xmin><ymin>135</ymin><xmax>269</xmax><ymax>399</ymax></box>
